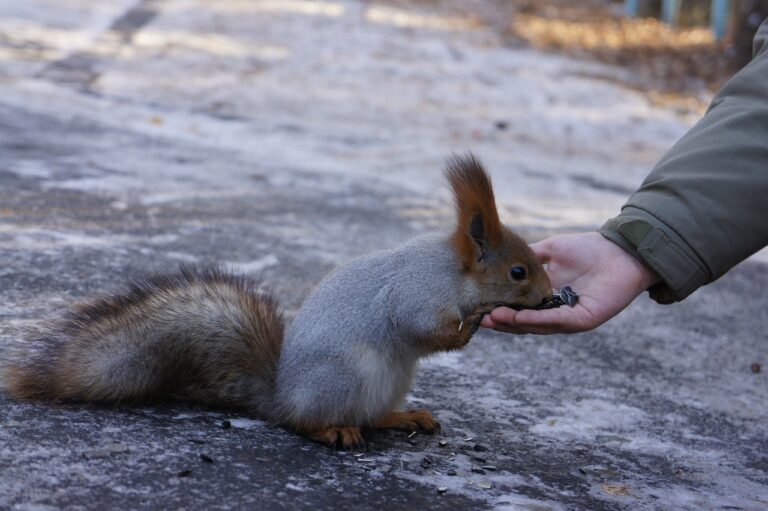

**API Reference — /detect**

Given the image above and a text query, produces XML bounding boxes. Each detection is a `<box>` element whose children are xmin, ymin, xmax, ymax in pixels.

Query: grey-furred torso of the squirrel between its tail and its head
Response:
<box><xmin>276</xmin><ymin>235</ymin><xmax>478</xmax><ymax>425</ymax></box>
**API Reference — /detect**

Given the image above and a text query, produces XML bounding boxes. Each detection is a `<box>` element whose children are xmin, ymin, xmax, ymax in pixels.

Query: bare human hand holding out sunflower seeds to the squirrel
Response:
<box><xmin>481</xmin><ymin>232</ymin><xmax>660</xmax><ymax>334</ymax></box>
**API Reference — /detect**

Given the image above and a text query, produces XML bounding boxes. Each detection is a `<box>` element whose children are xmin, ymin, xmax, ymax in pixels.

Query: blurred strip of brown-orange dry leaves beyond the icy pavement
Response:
<box><xmin>378</xmin><ymin>0</ymin><xmax>733</xmax><ymax>109</ymax></box>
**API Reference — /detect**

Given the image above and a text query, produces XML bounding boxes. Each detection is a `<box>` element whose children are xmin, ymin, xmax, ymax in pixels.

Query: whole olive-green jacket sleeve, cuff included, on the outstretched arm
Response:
<box><xmin>600</xmin><ymin>20</ymin><xmax>768</xmax><ymax>303</ymax></box>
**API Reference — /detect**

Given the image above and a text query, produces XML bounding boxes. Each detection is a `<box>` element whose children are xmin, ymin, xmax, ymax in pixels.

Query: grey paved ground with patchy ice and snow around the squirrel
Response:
<box><xmin>0</xmin><ymin>0</ymin><xmax>768</xmax><ymax>510</ymax></box>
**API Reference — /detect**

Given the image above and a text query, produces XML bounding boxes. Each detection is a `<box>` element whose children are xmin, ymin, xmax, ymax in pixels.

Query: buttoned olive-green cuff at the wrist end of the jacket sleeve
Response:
<box><xmin>600</xmin><ymin>206</ymin><xmax>710</xmax><ymax>304</ymax></box>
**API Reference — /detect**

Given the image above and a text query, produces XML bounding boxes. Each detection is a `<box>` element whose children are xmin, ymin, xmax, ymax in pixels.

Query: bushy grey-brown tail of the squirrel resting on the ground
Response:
<box><xmin>6</xmin><ymin>266</ymin><xmax>284</xmax><ymax>419</ymax></box>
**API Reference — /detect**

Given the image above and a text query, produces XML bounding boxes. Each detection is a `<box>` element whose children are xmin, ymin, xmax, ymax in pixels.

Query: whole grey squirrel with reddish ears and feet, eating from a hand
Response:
<box><xmin>6</xmin><ymin>154</ymin><xmax>553</xmax><ymax>449</ymax></box>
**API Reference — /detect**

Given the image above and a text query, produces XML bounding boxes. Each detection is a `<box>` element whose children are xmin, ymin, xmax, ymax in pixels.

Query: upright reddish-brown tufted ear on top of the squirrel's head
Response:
<box><xmin>445</xmin><ymin>153</ymin><xmax>502</xmax><ymax>268</ymax></box>
